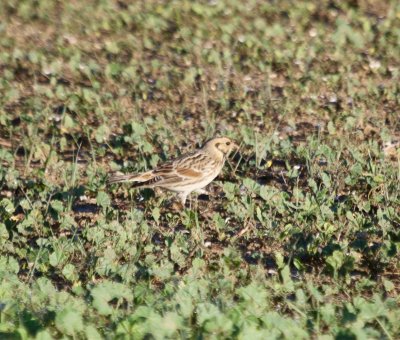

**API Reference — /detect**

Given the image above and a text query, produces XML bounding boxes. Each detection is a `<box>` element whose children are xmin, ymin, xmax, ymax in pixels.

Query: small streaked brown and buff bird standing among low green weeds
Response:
<box><xmin>108</xmin><ymin>137</ymin><xmax>239</xmax><ymax>206</ymax></box>
